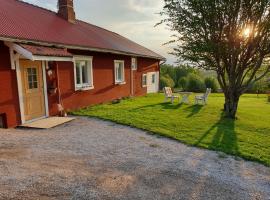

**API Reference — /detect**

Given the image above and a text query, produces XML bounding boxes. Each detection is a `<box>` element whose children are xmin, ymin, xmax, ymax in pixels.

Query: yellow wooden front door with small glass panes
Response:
<box><xmin>20</xmin><ymin>60</ymin><xmax>46</xmax><ymax>121</ymax></box>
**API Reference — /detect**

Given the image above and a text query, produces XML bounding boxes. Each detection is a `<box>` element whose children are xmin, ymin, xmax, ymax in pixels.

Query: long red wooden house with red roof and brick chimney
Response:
<box><xmin>0</xmin><ymin>0</ymin><xmax>164</xmax><ymax>127</ymax></box>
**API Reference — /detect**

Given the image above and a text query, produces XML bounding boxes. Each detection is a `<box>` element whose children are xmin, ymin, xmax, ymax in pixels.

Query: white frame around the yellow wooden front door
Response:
<box><xmin>16</xmin><ymin>59</ymin><xmax>49</xmax><ymax>124</ymax></box>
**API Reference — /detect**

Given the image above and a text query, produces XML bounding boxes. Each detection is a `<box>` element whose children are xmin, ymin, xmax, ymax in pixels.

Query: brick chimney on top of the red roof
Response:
<box><xmin>58</xmin><ymin>0</ymin><xmax>76</xmax><ymax>24</ymax></box>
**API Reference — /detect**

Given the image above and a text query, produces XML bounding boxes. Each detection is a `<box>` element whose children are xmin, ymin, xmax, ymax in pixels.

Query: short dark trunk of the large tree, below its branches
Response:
<box><xmin>224</xmin><ymin>93</ymin><xmax>240</xmax><ymax>119</ymax></box>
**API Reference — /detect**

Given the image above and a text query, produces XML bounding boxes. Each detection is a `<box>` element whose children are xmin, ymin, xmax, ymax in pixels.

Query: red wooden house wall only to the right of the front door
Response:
<box><xmin>49</xmin><ymin>51</ymin><xmax>159</xmax><ymax>115</ymax></box>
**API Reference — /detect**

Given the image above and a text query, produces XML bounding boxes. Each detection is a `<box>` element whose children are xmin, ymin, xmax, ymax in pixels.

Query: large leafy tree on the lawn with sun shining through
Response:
<box><xmin>161</xmin><ymin>0</ymin><xmax>270</xmax><ymax>118</ymax></box>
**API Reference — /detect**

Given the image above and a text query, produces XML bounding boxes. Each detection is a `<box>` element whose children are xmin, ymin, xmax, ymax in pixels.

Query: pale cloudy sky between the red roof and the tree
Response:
<box><xmin>24</xmin><ymin>0</ymin><xmax>176</xmax><ymax>63</ymax></box>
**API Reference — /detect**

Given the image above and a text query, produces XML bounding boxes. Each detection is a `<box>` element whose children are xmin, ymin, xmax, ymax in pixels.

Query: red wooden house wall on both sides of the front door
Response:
<box><xmin>0</xmin><ymin>43</ymin><xmax>159</xmax><ymax>127</ymax></box>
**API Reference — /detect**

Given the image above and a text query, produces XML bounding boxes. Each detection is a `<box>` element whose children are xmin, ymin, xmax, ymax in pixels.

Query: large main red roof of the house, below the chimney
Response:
<box><xmin>0</xmin><ymin>0</ymin><xmax>164</xmax><ymax>59</ymax></box>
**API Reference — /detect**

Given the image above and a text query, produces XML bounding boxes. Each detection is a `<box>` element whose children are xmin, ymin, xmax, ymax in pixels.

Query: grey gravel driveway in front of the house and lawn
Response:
<box><xmin>0</xmin><ymin>118</ymin><xmax>270</xmax><ymax>200</ymax></box>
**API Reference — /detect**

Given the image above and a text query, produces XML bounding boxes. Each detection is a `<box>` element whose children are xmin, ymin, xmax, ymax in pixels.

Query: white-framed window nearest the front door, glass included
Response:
<box><xmin>75</xmin><ymin>57</ymin><xmax>94</xmax><ymax>90</ymax></box>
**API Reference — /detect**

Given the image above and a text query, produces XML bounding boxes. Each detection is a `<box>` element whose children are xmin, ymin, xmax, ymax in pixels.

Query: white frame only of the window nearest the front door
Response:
<box><xmin>73</xmin><ymin>56</ymin><xmax>94</xmax><ymax>91</ymax></box>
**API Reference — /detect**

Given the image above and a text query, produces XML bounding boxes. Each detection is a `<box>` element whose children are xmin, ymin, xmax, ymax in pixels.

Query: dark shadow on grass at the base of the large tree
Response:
<box><xmin>194</xmin><ymin>113</ymin><xmax>238</xmax><ymax>155</ymax></box>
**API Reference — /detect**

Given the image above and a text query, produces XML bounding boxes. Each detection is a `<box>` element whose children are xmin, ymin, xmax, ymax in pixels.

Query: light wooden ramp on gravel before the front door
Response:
<box><xmin>21</xmin><ymin>117</ymin><xmax>75</xmax><ymax>129</ymax></box>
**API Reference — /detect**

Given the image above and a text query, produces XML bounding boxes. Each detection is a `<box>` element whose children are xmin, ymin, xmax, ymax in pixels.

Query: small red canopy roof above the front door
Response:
<box><xmin>19</xmin><ymin>44</ymin><xmax>73</xmax><ymax>57</ymax></box>
